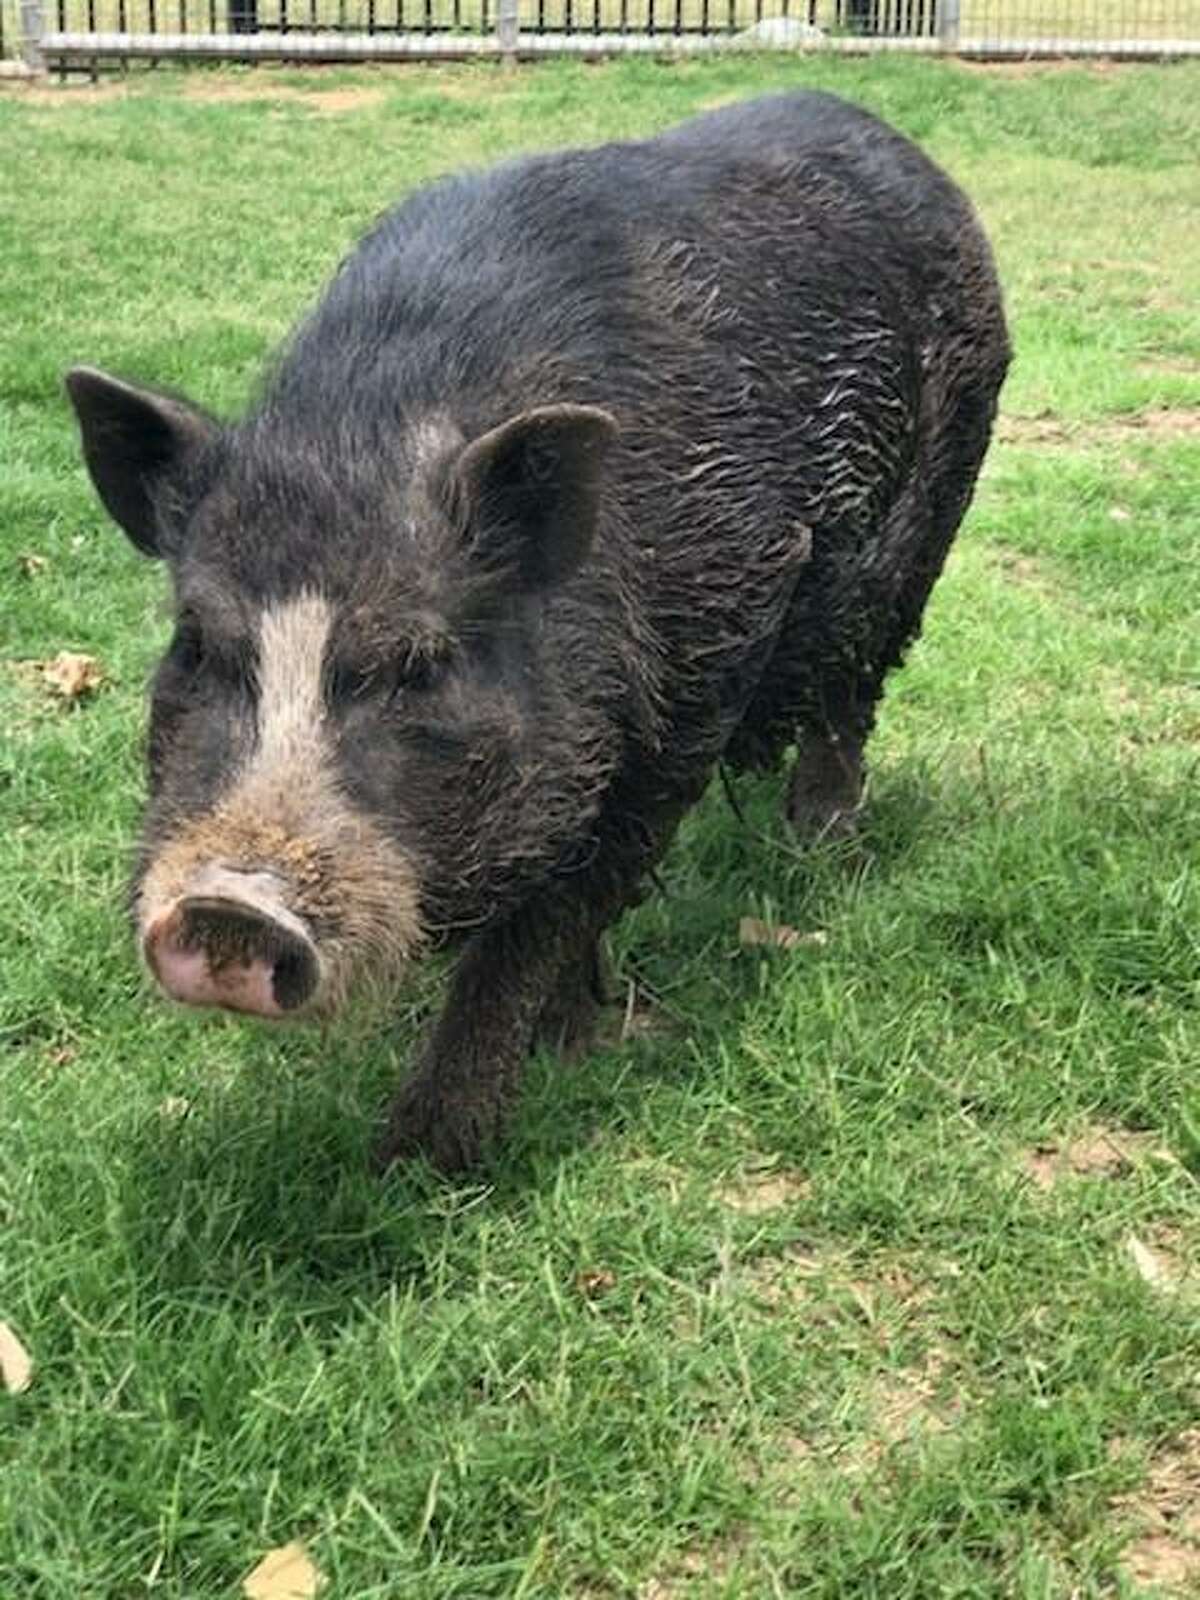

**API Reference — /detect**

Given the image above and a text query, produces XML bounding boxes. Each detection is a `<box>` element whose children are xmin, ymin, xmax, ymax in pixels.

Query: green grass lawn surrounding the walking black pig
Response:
<box><xmin>0</xmin><ymin>50</ymin><xmax>1200</xmax><ymax>1600</ymax></box>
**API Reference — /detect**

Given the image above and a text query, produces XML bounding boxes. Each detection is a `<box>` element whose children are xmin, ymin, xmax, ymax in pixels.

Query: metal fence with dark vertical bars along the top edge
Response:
<box><xmin>0</xmin><ymin>0</ymin><xmax>1200</xmax><ymax>70</ymax></box>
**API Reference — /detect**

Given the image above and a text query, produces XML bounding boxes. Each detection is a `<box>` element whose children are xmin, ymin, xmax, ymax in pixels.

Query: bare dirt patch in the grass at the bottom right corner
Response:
<box><xmin>1115</xmin><ymin>1427</ymin><xmax>1200</xmax><ymax>1594</ymax></box>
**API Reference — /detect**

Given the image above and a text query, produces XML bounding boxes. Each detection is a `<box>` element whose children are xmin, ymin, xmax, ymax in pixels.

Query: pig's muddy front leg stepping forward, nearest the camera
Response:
<box><xmin>376</xmin><ymin>909</ymin><xmax>582</xmax><ymax>1173</ymax></box>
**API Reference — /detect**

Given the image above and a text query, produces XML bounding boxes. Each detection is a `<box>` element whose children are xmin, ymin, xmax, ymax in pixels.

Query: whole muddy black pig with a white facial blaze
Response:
<box><xmin>66</xmin><ymin>93</ymin><xmax>1008</xmax><ymax>1171</ymax></box>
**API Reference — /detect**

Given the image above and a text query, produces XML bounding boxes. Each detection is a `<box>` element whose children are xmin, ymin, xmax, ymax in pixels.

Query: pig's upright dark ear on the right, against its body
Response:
<box><xmin>454</xmin><ymin>405</ymin><xmax>618</xmax><ymax>590</ymax></box>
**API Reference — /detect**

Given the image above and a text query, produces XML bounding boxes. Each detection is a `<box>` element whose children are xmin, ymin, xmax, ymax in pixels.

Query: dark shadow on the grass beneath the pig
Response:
<box><xmin>114</xmin><ymin>768</ymin><xmax>947</xmax><ymax>1309</ymax></box>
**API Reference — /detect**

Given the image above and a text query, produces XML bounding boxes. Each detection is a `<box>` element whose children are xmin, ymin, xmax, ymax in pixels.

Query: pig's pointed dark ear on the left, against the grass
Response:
<box><xmin>66</xmin><ymin>366</ymin><xmax>218</xmax><ymax>555</ymax></box>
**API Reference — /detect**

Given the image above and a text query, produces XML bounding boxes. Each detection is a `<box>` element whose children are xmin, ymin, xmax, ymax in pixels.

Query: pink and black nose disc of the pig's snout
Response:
<box><xmin>142</xmin><ymin>866</ymin><xmax>320</xmax><ymax>1018</ymax></box>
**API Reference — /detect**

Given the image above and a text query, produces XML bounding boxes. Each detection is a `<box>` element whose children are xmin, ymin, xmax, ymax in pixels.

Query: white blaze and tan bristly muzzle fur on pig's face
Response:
<box><xmin>138</xmin><ymin>590</ymin><xmax>421</xmax><ymax>1013</ymax></box>
